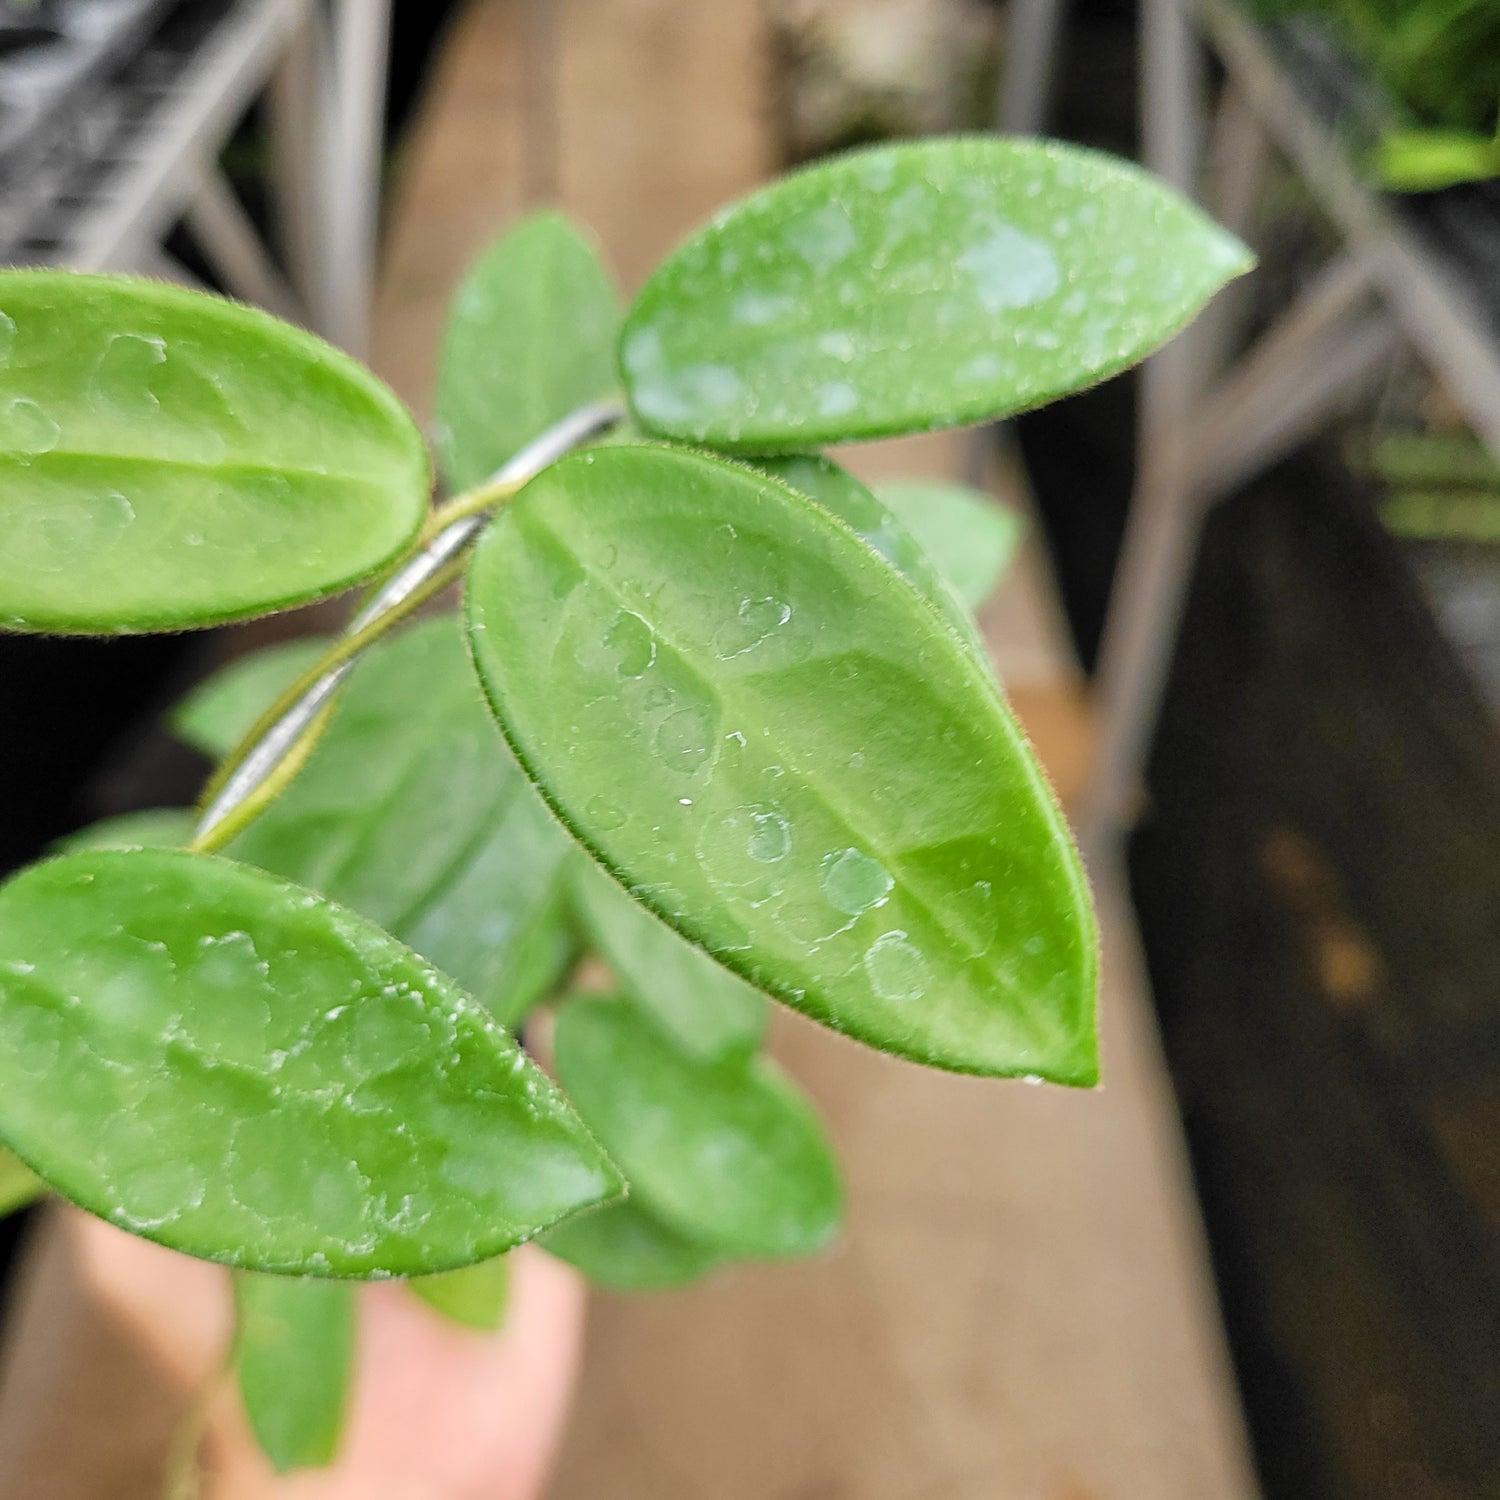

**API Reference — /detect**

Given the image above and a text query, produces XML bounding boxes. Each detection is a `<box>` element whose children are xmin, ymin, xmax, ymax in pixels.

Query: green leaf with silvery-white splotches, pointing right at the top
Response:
<box><xmin>621</xmin><ymin>137</ymin><xmax>1251</xmax><ymax>453</ymax></box>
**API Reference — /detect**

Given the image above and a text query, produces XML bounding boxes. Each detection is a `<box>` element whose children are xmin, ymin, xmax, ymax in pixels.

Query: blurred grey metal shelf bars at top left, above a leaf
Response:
<box><xmin>0</xmin><ymin>0</ymin><xmax>390</xmax><ymax>356</ymax></box>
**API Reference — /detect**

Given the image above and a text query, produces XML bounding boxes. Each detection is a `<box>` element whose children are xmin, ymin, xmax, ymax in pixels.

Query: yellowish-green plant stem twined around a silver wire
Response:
<box><xmin>188</xmin><ymin>401</ymin><xmax>624</xmax><ymax>854</ymax></box>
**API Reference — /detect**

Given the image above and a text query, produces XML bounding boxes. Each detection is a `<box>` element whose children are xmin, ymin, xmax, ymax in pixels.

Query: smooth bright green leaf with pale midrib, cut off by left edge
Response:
<box><xmin>0</xmin><ymin>270</ymin><xmax>431</xmax><ymax>635</ymax></box>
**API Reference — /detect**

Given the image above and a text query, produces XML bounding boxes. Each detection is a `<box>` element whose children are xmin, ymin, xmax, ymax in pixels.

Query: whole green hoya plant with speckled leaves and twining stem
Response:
<box><xmin>0</xmin><ymin>138</ymin><xmax>1248</xmax><ymax>1469</ymax></box>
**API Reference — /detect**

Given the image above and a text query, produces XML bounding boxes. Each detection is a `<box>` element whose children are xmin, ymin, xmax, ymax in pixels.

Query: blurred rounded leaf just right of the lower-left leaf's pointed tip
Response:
<box><xmin>552</xmin><ymin>999</ymin><xmax>842</xmax><ymax>1257</ymax></box>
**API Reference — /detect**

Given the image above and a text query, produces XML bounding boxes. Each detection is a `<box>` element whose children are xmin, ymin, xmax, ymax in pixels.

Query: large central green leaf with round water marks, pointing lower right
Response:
<box><xmin>468</xmin><ymin>447</ymin><xmax>1098</xmax><ymax>1083</ymax></box>
